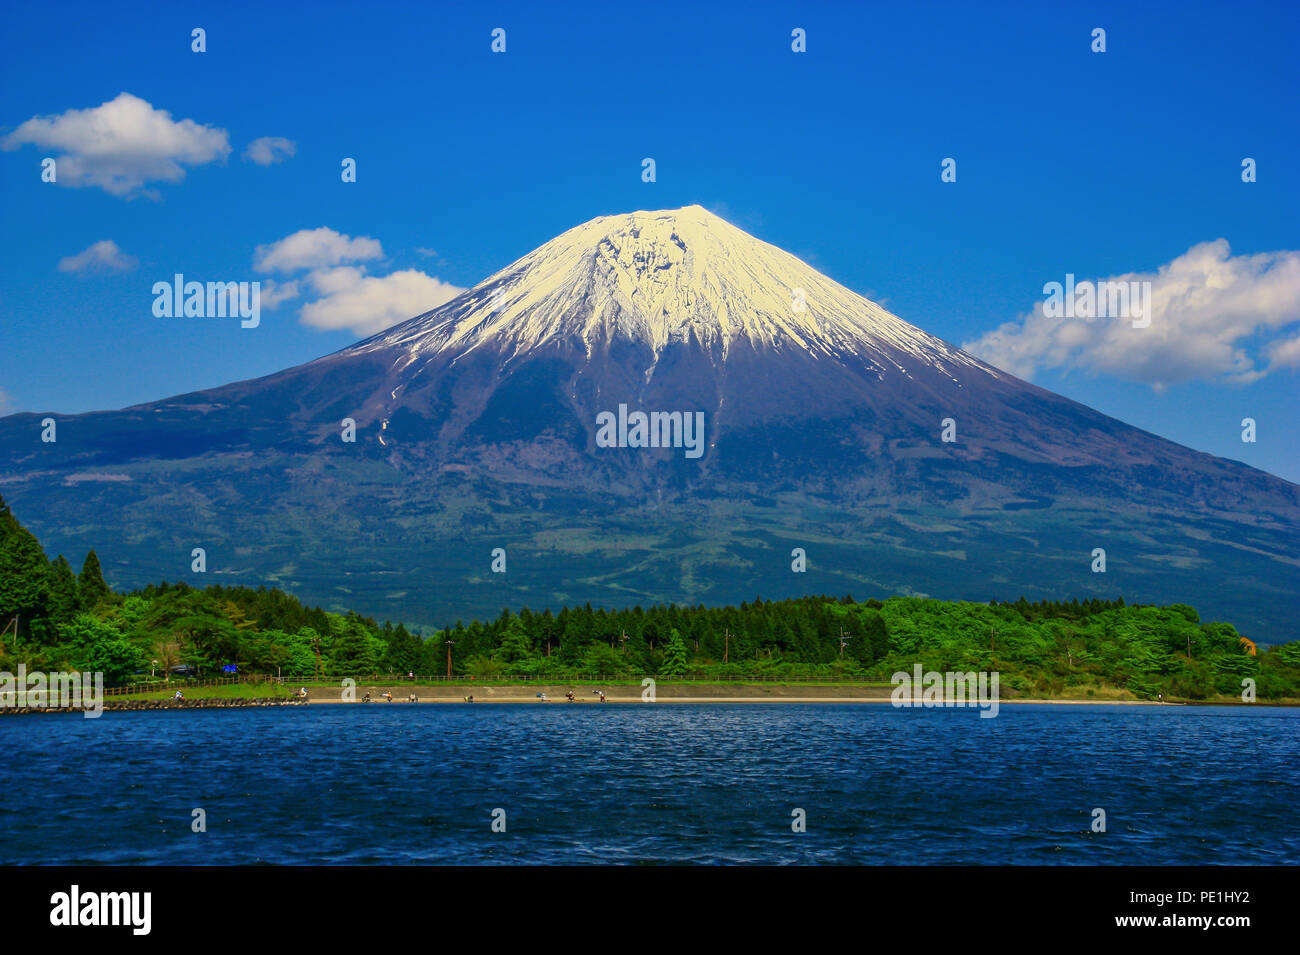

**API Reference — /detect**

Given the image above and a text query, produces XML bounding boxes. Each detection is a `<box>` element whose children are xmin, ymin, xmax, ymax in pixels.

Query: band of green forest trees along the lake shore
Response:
<box><xmin>0</xmin><ymin>499</ymin><xmax>1300</xmax><ymax>700</ymax></box>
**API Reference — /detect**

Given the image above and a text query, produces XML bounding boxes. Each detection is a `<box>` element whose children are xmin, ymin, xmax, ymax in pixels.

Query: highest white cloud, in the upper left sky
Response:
<box><xmin>0</xmin><ymin>92</ymin><xmax>230</xmax><ymax>197</ymax></box>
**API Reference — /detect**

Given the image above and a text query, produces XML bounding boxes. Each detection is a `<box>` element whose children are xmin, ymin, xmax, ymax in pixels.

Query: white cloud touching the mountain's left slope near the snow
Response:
<box><xmin>302</xmin><ymin>266</ymin><xmax>464</xmax><ymax>335</ymax></box>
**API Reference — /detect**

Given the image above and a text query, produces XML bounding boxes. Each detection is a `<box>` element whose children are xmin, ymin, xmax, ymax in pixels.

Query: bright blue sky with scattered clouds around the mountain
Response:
<box><xmin>0</xmin><ymin>3</ymin><xmax>1300</xmax><ymax>481</ymax></box>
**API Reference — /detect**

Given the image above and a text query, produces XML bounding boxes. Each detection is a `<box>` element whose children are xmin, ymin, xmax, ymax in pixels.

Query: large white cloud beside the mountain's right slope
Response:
<box><xmin>962</xmin><ymin>239</ymin><xmax>1300</xmax><ymax>388</ymax></box>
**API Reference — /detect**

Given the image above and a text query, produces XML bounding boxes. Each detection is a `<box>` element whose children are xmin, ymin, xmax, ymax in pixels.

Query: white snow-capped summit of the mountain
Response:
<box><xmin>356</xmin><ymin>205</ymin><xmax>983</xmax><ymax>382</ymax></box>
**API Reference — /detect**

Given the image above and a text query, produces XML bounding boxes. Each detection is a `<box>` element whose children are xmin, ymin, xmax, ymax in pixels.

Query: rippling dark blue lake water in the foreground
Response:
<box><xmin>0</xmin><ymin>703</ymin><xmax>1300</xmax><ymax>864</ymax></box>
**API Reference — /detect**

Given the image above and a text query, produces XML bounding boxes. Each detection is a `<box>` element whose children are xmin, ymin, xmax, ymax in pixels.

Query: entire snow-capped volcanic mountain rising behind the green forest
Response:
<box><xmin>0</xmin><ymin>207</ymin><xmax>1300</xmax><ymax>642</ymax></box>
